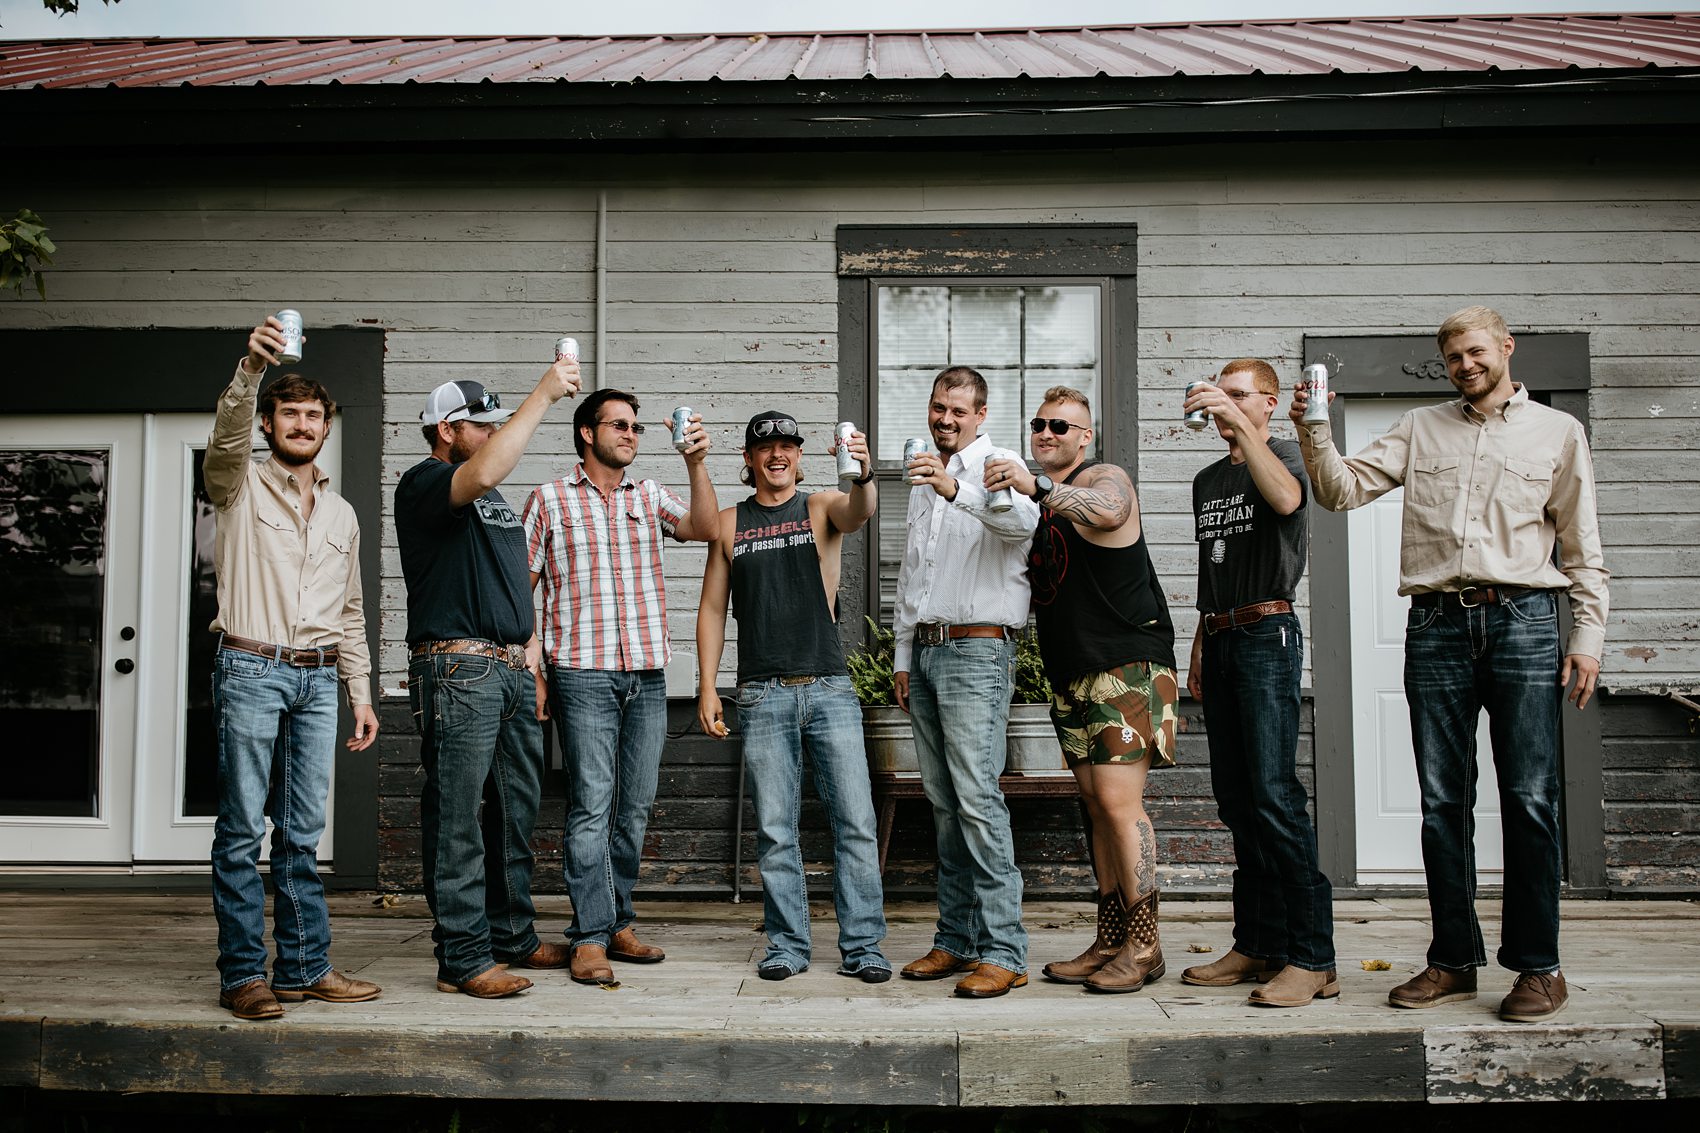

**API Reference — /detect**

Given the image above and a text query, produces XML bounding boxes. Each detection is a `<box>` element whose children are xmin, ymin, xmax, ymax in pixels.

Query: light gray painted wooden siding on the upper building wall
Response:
<box><xmin>0</xmin><ymin>141</ymin><xmax>1700</xmax><ymax>691</ymax></box>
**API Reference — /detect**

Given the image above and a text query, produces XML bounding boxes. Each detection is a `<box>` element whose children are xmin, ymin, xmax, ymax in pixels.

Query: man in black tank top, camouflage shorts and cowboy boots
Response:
<box><xmin>986</xmin><ymin>386</ymin><xmax>1178</xmax><ymax>992</ymax></box>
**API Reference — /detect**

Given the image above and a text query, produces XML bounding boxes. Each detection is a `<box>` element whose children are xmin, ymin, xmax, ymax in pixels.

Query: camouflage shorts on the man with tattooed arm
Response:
<box><xmin>1051</xmin><ymin>662</ymin><xmax>1180</xmax><ymax>767</ymax></box>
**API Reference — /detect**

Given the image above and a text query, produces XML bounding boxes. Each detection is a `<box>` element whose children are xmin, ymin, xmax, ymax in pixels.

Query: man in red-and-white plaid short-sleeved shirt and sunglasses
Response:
<box><xmin>525</xmin><ymin>390</ymin><xmax>719</xmax><ymax>985</ymax></box>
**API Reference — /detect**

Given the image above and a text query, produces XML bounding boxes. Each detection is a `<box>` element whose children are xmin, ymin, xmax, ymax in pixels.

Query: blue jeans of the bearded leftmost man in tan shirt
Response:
<box><xmin>213</xmin><ymin>648</ymin><xmax>337</xmax><ymax>992</ymax></box>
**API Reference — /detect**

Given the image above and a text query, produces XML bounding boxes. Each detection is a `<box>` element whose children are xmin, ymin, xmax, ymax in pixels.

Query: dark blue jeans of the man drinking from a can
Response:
<box><xmin>1202</xmin><ymin>614</ymin><xmax>1335</xmax><ymax>971</ymax></box>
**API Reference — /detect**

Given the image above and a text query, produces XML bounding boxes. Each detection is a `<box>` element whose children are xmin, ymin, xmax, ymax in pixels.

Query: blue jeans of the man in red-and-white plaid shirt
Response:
<box><xmin>549</xmin><ymin>669</ymin><xmax>666</xmax><ymax>946</ymax></box>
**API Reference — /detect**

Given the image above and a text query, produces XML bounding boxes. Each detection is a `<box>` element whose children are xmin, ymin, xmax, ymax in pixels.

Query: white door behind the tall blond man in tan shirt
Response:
<box><xmin>1343</xmin><ymin>398</ymin><xmax>1503</xmax><ymax>885</ymax></box>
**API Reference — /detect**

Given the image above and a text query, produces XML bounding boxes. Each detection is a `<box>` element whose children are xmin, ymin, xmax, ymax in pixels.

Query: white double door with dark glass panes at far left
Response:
<box><xmin>0</xmin><ymin>413</ymin><xmax>340</xmax><ymax>871</ymax></box>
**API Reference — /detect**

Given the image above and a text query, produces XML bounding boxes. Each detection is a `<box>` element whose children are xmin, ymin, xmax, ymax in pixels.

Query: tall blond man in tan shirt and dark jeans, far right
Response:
<box><xmin>1290</xmin><ymin>306</ymin><xmax>1608</xmax><ymax>1022</ymax></box>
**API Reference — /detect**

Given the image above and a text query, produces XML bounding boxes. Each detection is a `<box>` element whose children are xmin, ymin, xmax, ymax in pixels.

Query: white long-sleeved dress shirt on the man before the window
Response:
<box><xmin>893</xmin><ymin>428</ymin><xmax>1039</xmax><ymax>672</ymax></box>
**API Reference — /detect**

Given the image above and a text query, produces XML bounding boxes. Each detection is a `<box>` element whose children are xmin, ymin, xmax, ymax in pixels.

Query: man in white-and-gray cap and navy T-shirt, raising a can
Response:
<box><xmin>396</xmin><ymin>359</ymin><xmax>578</xmax><ymax>999</ymax></box>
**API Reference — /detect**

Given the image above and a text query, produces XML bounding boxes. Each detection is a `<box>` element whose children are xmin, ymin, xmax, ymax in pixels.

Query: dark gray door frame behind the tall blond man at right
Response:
<box><xmin>1304</xmin><ymin>332</ymin><xmax>1607</xmax><ymax>897</ymax></box>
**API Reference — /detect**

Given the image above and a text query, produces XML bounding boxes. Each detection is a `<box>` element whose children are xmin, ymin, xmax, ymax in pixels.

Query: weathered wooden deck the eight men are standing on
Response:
<box><xmin>0</xmin><ymin>891</ymin><xmax>1700</xmax><ymax>1106</ymax></box>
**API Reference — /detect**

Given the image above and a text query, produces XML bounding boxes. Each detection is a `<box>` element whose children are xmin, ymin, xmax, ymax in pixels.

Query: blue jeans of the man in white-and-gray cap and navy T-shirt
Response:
<box><xmin>408</xmin><ymin>653</ymin><xmax>542</xmax><ymax>983</ymax></box>
